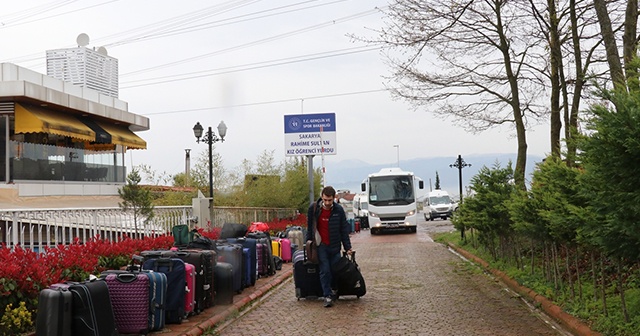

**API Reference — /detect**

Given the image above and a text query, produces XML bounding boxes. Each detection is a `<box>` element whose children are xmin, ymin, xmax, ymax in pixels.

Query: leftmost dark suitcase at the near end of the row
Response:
<box><xmin>36</xmin><ymin>288</ymin><xmax>72</xmax><ymax>336</ymax></box>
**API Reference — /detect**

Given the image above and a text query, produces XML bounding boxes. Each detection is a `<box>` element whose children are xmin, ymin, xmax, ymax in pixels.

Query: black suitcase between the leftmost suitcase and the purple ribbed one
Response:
<box><xmin>68</xmin><ymin>280</ymin><xmax>118</xmax><ymax>336</ymax></box>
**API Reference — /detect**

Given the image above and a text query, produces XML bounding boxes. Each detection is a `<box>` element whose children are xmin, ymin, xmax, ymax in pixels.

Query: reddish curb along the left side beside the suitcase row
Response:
<box><xmin>180</xmin><ymin>268</ymin><xmax>293</xmax><ymax>336</ymax></box>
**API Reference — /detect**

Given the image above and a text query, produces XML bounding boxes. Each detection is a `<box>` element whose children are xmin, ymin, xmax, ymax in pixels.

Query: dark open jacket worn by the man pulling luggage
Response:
<box><xmin>306</xmin><ymin>198</ymin><xmax>351</xmax><ymax>253</ymax></box>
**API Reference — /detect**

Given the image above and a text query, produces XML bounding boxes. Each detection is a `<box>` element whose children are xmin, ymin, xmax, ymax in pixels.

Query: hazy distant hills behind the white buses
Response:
<box><xmin>322</xmin><ymin>154</ymin><xmax>543</xmax><ymax>198</ymax></box>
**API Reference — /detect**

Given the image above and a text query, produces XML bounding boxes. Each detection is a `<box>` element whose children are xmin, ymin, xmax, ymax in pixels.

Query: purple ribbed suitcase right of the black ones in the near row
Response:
<box><xmin>105</xmin><ymin>273</ymin><xmax>149</xmax><ymax>334</ymax></box>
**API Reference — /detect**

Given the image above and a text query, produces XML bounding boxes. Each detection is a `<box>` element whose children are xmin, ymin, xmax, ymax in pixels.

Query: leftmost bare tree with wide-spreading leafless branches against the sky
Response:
<box><xmin>380</xmin><ymin>0</ymin><xmax>547</xmax><ymax>188</ymax></box>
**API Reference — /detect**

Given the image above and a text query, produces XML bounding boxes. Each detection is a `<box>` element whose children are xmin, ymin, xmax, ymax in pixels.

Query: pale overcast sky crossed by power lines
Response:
<box><xmin>0</xmin><ymin>0</ymin><xmax>549</xmax><ymax>184</ymax></box>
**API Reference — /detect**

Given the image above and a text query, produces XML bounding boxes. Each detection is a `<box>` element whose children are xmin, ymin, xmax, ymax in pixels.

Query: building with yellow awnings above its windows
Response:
<box><xmin>0</xmin><ymin>63</ymin><xmax>149</xmax><ymax>197</ymax></box>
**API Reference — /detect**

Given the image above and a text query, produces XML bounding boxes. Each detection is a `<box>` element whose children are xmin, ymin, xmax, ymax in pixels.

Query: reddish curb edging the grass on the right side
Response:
<box><xmin>447</xmin><ymin>243</ymin><xmax>602</xmax><ymax>336</ymax></box>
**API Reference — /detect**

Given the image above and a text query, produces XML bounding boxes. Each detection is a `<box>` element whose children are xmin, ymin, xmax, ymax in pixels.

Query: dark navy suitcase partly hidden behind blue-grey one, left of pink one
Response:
<box><xmin>142</xmin><ymin>258</ymin><xmax>187</xmax><ymax>324</ymax></box>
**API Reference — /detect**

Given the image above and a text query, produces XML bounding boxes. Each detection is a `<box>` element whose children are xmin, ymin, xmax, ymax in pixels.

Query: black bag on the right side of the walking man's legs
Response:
<box><xmin>331</xmin><ymin>251</ymin><xmax>367</xmax><ymax>298</ymax></box>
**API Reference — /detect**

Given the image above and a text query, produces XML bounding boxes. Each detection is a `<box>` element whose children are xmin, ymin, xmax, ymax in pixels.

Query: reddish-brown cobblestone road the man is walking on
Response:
<box><xmin>212</xmin><ymin>217</ymin><xmax>563</xmax><ymax>336</ymax></box>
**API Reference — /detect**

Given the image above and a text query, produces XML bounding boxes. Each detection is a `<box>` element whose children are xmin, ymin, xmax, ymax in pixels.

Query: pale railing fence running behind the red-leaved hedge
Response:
<box><xmin>0</xmin><ymin>206</ymin><xmax>297</xmax><ymax>251</ymax></box>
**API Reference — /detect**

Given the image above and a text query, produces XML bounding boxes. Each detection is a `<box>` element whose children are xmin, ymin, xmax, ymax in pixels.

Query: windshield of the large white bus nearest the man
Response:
<box><xmin>369</xmin><ymin>176</ymin><xmax>415</xmax><ymax>206</ymax></box>
